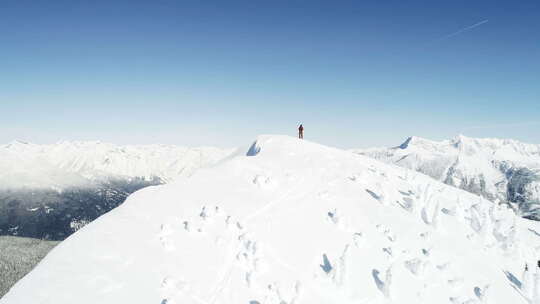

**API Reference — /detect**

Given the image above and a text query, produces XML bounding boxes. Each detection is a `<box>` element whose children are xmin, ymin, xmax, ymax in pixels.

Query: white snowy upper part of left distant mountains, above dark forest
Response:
<box><xmin>0</xmin><ymin>141</ymin><xmax>233</xmax><ymax>189</ymax></box>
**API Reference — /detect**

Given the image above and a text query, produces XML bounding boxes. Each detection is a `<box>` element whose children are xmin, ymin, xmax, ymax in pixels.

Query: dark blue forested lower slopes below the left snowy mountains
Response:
<box><xmin>0</xmin><ymin>178</ymin><xmax>161</xmax><ymax>240</ymax></box>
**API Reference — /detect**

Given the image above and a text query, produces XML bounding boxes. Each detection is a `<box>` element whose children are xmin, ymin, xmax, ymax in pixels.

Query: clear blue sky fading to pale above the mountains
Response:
<box><xmin>0</xmin><ymin>0</ymin><xmax>540</xmax><ymax>148</ymax></box>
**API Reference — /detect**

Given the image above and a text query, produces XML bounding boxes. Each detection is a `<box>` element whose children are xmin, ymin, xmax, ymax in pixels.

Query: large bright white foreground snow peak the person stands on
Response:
<box><xmin>4</xmin><ymin>136</ymin><xmax>540</xmax><ymax>304</ymax></box>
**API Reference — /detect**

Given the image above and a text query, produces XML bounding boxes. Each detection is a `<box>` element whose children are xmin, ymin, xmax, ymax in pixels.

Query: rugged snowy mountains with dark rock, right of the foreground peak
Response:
<box><xmin>354</xmin><ymin>136</ymin><xmax>540</xmax><ymax>220</ymax></box>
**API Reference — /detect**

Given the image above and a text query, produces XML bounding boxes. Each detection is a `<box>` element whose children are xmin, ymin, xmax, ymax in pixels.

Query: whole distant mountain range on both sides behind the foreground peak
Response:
<box><xmin>4</xmin><ymin>136</ymin><xmax>540</xmax><ymax>240</ymax></box>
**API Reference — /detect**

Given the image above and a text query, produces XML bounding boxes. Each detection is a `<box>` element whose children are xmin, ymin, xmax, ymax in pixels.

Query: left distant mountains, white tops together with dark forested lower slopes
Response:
<box><xmin>0</xmin><ymin>141</ymin><xmax>233</xmax><ymax>240</ymax></box>
